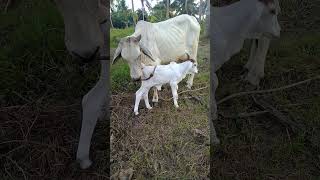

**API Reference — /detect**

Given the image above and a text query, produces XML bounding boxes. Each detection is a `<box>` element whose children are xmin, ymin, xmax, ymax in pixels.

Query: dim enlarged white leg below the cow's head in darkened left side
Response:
<box><xmin>77</xmin><ymin>80</ymin><xmax>107</xmax><ymax>169</ymax></box>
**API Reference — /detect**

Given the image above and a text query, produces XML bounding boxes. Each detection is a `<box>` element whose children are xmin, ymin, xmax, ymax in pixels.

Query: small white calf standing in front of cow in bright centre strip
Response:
<box><xmin>134</xmin><ymin>60</ymin><xmax>198</xmax><ymax>115</ymax></box>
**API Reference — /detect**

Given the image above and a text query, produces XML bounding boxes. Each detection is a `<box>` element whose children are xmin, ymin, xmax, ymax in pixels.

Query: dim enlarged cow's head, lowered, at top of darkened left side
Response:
<box><xmin>55</xmin><ymin>0</ymin><xmax>108</xmax><ymax>62</ymax></box>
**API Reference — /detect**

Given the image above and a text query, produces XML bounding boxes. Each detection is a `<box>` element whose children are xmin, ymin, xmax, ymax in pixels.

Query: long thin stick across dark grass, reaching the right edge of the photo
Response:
<box><xmin>217</xmin><ymin>76</ymin><xmax>320</xmax><ymax>104</ymax></box>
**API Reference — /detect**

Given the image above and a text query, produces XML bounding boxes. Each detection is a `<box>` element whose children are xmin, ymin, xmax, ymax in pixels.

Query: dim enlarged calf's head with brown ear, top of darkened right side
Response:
<box><xmin>253</xmin><ymin>0</ymin><xmax>281</xmax><ymax>37</ymax></box>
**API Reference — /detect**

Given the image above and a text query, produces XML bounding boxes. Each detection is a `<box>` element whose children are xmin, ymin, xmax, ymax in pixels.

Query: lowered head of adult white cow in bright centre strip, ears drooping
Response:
<box><xmin>112</xmin><ymin>35</ymin><xmax>154</xmax><ymax>80</ymax></box>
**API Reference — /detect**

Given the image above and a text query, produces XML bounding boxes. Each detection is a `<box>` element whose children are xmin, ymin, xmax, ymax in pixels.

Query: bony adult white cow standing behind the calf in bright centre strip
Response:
<box><xmin>113</xmin><ymin>14</ymin><xmax>200</xmax><ymax>102</ymax></box>
